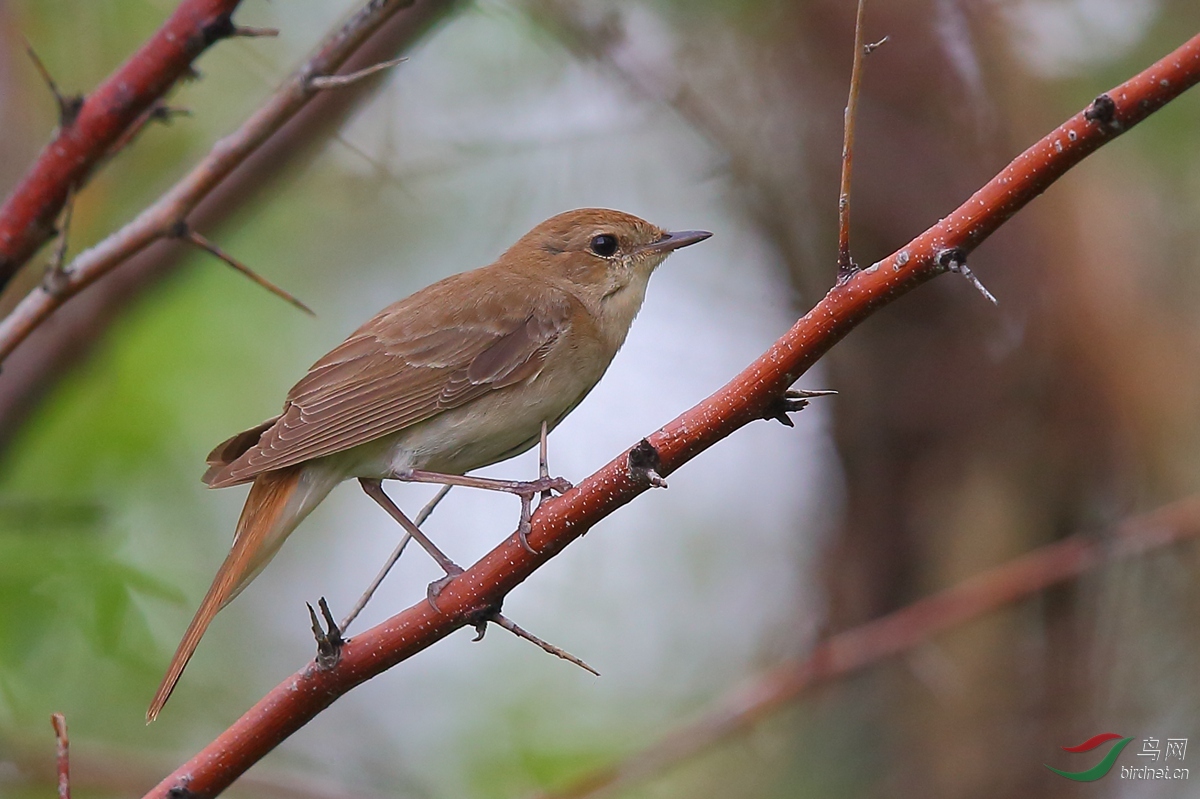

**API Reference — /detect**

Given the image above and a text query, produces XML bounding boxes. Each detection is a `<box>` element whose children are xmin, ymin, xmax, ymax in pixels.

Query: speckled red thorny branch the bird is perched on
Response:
<box><xmin>146</xmin><ymin>36</ymin><xmax>1200</xmax><ymax>799</ymax></box>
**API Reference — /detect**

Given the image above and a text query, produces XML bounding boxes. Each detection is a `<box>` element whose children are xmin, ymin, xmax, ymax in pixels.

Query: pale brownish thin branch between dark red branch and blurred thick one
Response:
<box><xmin>0</xmin><ymin>0</ymin><xmax>455</xmax><ymax>360</ymax></box>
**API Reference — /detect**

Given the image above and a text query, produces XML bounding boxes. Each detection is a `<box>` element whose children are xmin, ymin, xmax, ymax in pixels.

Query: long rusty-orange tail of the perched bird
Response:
<box><xmin>146</xmin><ymin>464</ymin><xmax>337</xmax><ymax>723</ymax></box>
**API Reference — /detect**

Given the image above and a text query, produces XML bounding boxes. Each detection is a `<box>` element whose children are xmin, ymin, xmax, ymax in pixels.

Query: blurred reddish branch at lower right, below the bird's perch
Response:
<box><xmin>542</xmin><ymin>498</ymin><xmax>1200</xmax><ymax>799</ymax></box>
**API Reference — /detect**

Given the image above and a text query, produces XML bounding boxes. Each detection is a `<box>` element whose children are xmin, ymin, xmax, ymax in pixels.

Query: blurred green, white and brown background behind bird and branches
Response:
<box><xmin>0</xmin><ymin>0</ymin><xmax>1200</xmax><ymax>799</ymax></box>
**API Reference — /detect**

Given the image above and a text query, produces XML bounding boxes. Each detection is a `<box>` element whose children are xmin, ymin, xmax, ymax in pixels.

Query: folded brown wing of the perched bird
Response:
<box><xmin>204</xmin><ymin>271</ymin><xmax>574</xmax><ymax>488</ymax></box>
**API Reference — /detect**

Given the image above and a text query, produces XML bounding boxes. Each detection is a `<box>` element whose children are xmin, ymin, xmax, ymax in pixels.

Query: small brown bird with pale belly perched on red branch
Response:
<box><xmin>146</xmin><ymin>209</ymin><xmax>712</xmax><ymax>721</ymax></box>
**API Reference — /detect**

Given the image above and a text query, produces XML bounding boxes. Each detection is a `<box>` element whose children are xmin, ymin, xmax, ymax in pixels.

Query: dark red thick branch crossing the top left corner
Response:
<box><xmin>0</xmin><ymin>0</ymin><xmax>241</xmax><ymax>288</ymax></box>
